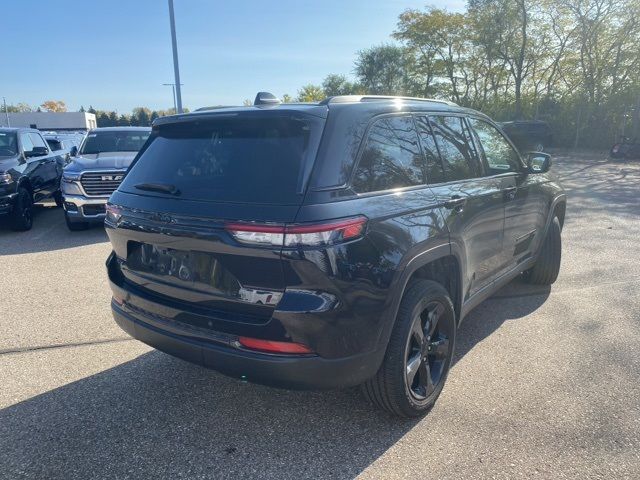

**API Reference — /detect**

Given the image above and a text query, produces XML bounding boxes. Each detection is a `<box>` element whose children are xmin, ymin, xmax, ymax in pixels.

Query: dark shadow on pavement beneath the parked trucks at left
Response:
<box><xmin>0</xmin><ymin>203</ymin><xmax>108</xmax><ymax>256</ymax></box>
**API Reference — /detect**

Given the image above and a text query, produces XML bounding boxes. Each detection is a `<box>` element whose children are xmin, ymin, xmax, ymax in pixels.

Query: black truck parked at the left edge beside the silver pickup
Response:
<box><xmin>0</xmin><ymin>128</ymin><xmax>64</xmax><ymax>230</ymax></box>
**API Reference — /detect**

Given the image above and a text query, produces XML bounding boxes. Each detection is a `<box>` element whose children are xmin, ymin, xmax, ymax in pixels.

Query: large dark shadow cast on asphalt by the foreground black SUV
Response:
<box><xmin>0</xmin><ymin>281</ymin><xmax>549</xmax><ymax>479</ymax></box>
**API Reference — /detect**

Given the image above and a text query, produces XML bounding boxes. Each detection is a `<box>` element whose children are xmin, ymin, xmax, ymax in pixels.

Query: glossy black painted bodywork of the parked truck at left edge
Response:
<box><xmin>0</xmin><ymin>128</ymin><xmax>66</xmax><ymax>214</ymax></box>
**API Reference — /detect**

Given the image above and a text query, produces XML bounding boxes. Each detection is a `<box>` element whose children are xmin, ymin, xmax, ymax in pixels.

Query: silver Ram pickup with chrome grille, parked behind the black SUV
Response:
<box><xmin>62</xmin><ymin>127</ymin><xmax>151</xmax><ymax>231</ymax></box>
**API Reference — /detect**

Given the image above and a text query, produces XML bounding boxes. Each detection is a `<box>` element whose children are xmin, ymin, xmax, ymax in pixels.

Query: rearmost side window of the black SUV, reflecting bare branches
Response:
<box><xmin>353</xmin><ymin>117</ymin><xmax>427</xmax><ymax>193</ymax></box>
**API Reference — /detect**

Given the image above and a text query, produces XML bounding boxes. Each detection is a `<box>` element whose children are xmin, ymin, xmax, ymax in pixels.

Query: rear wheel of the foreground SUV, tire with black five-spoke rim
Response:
<box><xmin>361</xmin><ymin>280</ymin><xmax>456</xmax><ymax>418</ymax></box>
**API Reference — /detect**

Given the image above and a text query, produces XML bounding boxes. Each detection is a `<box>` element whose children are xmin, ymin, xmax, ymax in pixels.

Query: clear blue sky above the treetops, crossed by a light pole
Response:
<box><xmin>0</xmin><ymin>0</ymin><xmax>465</xmax><ymax>113</ymax></box>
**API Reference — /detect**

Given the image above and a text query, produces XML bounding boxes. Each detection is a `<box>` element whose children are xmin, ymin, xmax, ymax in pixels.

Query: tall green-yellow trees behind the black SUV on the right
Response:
<box><xmin>288</xmin><ymin>0</ymin><xmax>640</xmax><ymax>147</ymax></box>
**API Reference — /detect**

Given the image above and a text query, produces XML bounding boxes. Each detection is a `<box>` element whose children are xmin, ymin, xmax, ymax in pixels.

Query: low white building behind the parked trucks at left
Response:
<box><xmin>0</xmin><ymin>112</ymin><xmax>97</xmax><ymax>132</ymax></box>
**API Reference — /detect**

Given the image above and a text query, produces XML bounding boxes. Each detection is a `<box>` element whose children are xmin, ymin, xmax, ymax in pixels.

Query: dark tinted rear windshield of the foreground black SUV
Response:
<box><xmin>121</xmin><ymin>112</ymin><xmax>324</xmax><ymax>205</ymax></box>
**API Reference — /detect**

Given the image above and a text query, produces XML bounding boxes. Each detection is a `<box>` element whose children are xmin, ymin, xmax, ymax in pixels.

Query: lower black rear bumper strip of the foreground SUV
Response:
<box><xmin>111</xmin><ymin>302</ymin><xmax>378</xmax><ymax>390</ymax></box>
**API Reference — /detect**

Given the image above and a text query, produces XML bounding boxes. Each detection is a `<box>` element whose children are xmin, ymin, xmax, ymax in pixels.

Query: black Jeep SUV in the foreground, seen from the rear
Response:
<box><xmin>105</xmin><ymin>95</ymin><xmax>565</xmax><ymax>416</ymax></box>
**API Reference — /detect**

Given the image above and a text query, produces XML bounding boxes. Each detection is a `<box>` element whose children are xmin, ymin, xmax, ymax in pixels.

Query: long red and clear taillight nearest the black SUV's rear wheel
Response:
<box><xmin>225</xmin><ymin>216</ymin><xmax>367</xmax><ymax>247</ymax></box>
